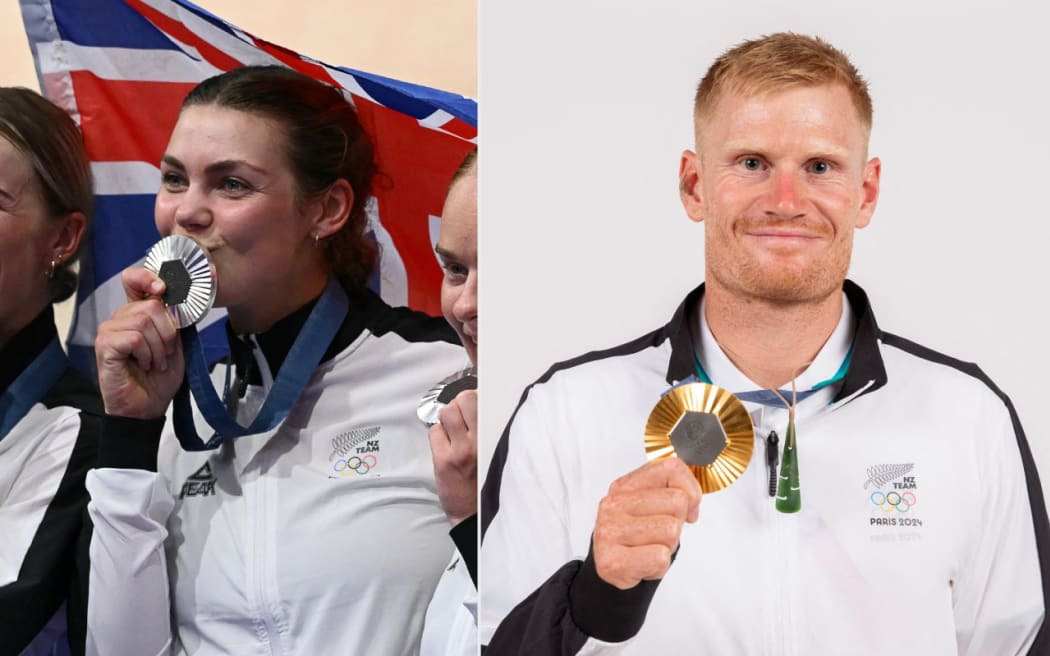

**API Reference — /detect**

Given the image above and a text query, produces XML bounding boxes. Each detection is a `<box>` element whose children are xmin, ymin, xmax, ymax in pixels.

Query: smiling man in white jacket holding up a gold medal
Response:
<box><xmin>481</xmin><ymin>34</ymin><xmax>1050</xmax><ymax>655</ymax></box>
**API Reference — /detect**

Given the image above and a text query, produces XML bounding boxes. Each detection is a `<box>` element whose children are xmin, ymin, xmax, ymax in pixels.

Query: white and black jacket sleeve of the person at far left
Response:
<box><xmin>0</xmin><ymin>408</ymin><xmax>98</xmax><ymax>655</ymax></box>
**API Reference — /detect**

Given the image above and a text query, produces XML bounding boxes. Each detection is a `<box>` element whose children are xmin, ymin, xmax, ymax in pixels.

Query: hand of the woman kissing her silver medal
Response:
<box><xmin>95</xmin><ymin>269</ymin><xmax>185</xmax><ymax>419</ymax></box>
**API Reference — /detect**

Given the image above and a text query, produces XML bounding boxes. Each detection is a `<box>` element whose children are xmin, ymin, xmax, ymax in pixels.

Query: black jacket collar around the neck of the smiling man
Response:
<box><xmin>664</xmin><ymin>280</ymin><xmax>886</xmax><ymax>402</ymax></box>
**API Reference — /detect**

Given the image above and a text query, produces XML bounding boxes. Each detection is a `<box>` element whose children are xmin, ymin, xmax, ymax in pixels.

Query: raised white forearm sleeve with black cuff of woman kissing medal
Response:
<box><xmin>87</xmin><ymin>417</ymin><xmax>174</xmax><ymax>656</ymax></box>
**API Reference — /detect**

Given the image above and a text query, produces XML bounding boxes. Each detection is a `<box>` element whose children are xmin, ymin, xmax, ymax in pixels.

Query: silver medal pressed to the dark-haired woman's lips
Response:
<box><xmin>143</xmin><ymin>235</ymin><xmax>215</xmax><ymax>329</ymax></box>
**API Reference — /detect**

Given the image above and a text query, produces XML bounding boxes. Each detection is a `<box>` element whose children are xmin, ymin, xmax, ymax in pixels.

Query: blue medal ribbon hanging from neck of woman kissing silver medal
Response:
<box><xmin>173</xmin><ymin>278</ymin><xmax>350</xmax><ymax>451</ymax></box>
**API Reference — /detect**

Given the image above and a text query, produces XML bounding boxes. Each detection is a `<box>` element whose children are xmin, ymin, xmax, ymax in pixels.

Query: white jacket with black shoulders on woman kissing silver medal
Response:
<box><xmin>87</xmin><ymin>295</ymin><xmax>466</xmax><ymax>656</ymax></box>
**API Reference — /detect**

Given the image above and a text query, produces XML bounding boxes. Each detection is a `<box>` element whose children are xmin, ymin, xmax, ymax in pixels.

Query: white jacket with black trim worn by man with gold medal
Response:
<box><xmin>480</xmin><ymin>281</ymin><xmax>1050</xmax><ymax>656</ymax></box>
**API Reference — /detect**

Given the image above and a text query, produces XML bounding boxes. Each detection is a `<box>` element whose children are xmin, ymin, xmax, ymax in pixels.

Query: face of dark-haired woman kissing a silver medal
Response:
<box><xmin>155</xmin><ymin>105</ymin><xmax>323</xmax><ymax>327</ymax></box>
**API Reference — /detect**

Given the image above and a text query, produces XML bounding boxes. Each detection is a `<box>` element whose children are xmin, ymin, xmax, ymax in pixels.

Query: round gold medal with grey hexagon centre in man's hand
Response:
<box><xmin>645</xmin><ymin>383</ymin><xmax>755</xmax><ymax>494</ymax></box>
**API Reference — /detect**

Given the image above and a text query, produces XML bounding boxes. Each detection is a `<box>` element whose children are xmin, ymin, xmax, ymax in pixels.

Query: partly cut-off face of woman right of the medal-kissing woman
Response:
<box><xmin>436</xmin><ymin>171</ymin><xmax>478</xmax><ymax>364</ymax></box>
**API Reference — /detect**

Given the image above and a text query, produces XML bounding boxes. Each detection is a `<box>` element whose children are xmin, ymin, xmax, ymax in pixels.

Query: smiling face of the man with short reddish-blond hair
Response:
<box><xmin>683</xmin><ymin>84</ymin><xmax>881</xmax><ymax>302</ymax></box>
